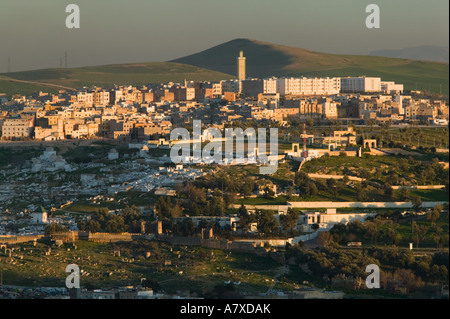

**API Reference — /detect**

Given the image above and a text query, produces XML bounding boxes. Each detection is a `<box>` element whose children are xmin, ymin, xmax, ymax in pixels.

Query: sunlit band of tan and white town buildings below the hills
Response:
<box><xmin>0</xmin><ymin>78</ymin><xmax>449</xmax><ymax>141</ymax></box>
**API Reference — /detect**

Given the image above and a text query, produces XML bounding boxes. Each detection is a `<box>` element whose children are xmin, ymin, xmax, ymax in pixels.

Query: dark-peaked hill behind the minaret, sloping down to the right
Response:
<box><xmin>172</xmin><ymin>39</ymin><xmax>449</xmax><ymax>94</ymax></box>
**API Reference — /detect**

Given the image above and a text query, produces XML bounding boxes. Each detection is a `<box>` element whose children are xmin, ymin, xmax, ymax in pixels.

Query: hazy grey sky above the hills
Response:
<box><xmin>0</xmin><ymin>0</ymin><xmax>449</xmax><ymax>72</ymax></box>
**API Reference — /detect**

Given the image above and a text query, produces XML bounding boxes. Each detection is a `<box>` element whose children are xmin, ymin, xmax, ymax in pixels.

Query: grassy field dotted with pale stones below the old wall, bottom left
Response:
<box><xmin>0</xmin><ymin>241</ymin><xmax>294</xmax><ymax>293</ymax></box>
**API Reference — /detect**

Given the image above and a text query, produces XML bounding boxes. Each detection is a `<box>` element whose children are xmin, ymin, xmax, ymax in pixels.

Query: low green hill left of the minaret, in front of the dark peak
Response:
<box><xmin>0</xmin><ymin>62</ymin><xmax>232</xmax><ymax>95</ymax></box>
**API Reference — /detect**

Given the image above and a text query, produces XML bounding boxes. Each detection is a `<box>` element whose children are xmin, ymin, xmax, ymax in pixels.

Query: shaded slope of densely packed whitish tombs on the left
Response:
<box><xmin>0</xmin><ymin>144</ymin><xmax>208</xmax><ymax>220</ymax></box>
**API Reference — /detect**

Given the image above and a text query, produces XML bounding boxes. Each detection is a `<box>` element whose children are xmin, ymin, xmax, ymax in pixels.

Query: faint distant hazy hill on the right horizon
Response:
<box><xmin>369</xmin><ymin>45</ymin><xmax>449</xmax><ymax>63</ymax></box>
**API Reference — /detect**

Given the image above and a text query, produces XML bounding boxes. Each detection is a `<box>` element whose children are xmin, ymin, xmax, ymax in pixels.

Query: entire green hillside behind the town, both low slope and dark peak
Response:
<box><xmin>0</xmin><ymin>39</ymin><xmax>449</xmax><ymax>95</ymax></box>
